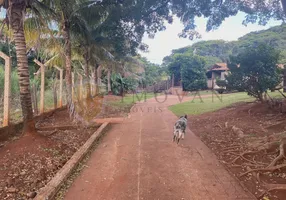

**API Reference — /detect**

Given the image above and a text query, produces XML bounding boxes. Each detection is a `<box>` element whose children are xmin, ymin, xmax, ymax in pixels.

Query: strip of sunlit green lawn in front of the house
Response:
<box><xmin>169</xmin><ymin>93</ymin><xmax>254</xmax><ymax>116</ymax></box>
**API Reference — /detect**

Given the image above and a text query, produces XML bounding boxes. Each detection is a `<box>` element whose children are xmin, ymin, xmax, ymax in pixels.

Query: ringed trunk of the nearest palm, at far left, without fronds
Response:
<box><xmin>9</xmin><ymin>1</ymin><xmax>36</xmax><ymax>134</ymax></box>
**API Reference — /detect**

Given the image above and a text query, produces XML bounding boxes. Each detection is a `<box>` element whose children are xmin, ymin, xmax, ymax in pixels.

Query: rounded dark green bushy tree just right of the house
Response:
<box><xmin>227</xmin><ymin>45</ymin><xmax>281</xmax><ymax>101</ymax></box>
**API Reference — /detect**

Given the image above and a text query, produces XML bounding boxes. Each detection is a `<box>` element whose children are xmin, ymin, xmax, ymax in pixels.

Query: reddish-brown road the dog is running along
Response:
<box><xmin>65</xmin><ymin>96</ymin><xmax>254</xmax><ymax>200</ymax></box>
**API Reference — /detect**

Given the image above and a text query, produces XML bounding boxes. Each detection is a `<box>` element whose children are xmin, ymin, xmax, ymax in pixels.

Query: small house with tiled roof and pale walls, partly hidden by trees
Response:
<box><xmin>206</xmin><ymin>63</ymin><xmax>229</xmax><ymax>89</ymax></box>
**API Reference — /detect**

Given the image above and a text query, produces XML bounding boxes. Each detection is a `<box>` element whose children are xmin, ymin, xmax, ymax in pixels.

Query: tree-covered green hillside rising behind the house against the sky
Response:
<box><xmin>164</xmin><ymin>25</ymin><xmax>286</xmax><ymax>67</ymax></box>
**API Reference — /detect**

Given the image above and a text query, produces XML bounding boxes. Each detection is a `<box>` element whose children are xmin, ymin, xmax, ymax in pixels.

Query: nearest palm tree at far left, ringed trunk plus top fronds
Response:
<box><xmin>0</xmin><ymin>0</ymin><xmax>53</xmax><ymax>134</ymax></box>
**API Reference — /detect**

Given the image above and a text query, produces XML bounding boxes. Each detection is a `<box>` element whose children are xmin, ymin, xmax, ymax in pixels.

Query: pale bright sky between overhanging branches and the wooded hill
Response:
<box><xmin>140</xmin><ymin>13</ymin><xmax>282</xmax><ymax>64</ymax></box>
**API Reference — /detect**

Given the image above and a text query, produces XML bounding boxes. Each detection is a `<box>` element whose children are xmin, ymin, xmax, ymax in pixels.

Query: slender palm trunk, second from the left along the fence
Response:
<box><xmin>63</xmin><ymin>22</ymin><xmax>72</xmax><ymax>108</ymax></box>
